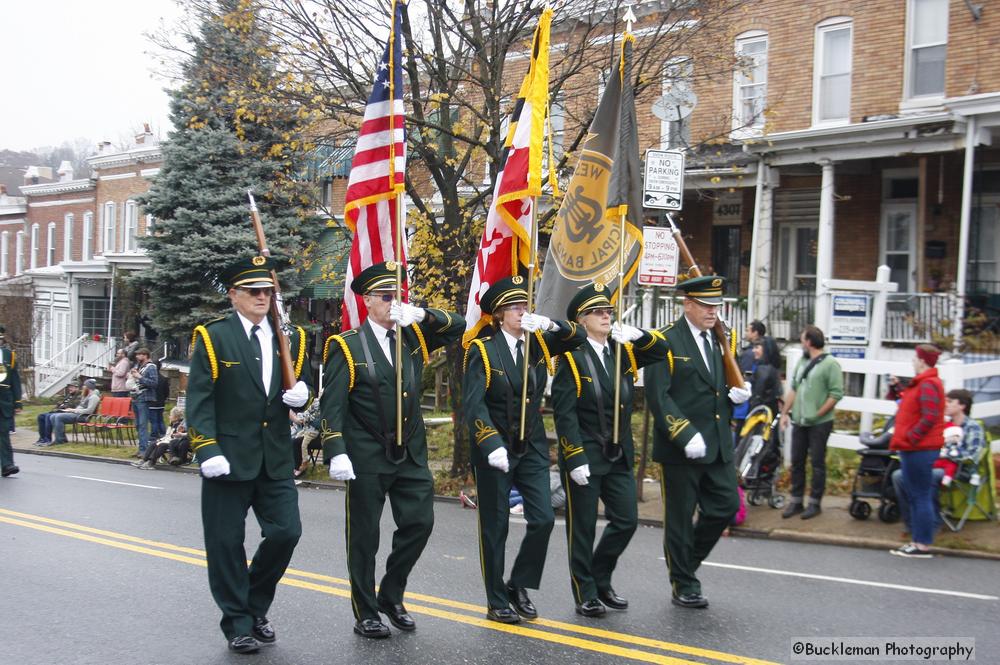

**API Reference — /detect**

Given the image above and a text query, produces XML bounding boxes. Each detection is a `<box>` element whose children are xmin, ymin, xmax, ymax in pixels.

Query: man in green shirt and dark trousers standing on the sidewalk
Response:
<box><xmin>781</xmin><ymin>325</ymin><xmax>844</xmax><ymax>520</ymax></box>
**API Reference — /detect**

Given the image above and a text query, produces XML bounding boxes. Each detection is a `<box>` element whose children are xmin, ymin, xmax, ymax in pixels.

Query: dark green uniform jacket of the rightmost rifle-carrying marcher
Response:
<box><xmin>645</xmin><ymin>317</ymin><xmax>733</xmax><ymax>464</ymax></box>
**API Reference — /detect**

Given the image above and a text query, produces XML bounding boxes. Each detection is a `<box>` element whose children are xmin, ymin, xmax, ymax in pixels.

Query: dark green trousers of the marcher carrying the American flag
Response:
<box><xmin>346</xmin><ymin>455</ymin><xmax>434</xmax><ymax>621</ymax></box>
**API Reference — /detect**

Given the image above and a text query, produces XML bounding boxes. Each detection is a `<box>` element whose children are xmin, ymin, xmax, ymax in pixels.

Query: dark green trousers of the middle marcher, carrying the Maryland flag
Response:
<box><xmin>474</xmin><ymin>447</ymin><xmax>555</xmax><ymax>609</ymax></box>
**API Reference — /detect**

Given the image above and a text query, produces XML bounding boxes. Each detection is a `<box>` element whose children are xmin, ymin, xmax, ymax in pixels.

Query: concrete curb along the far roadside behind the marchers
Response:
<box><xmin>14</xmin><ymin>448</ymin><xmax>1000</xmax><ymax>561</ymax></box>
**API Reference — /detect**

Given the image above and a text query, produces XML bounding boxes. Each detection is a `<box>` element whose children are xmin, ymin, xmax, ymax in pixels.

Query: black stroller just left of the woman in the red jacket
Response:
<box><xmin>849</xmin><ymin>417</ymin><xmax>899</xmax><ymax>524</ymax></box>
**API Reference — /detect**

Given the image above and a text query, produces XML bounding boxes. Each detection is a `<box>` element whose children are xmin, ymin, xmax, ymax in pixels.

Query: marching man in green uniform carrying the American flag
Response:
<box><xmin>320</xmin><ymin>261</ymin><xmax>465</xmax><ymax>638</ymax></box>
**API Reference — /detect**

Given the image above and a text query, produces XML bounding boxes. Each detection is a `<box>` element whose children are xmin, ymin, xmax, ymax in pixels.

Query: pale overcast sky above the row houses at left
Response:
<box><xmin>0</xmin><ymin>0</ymin><xmax>178</xmax><ymax>150</ymax></box>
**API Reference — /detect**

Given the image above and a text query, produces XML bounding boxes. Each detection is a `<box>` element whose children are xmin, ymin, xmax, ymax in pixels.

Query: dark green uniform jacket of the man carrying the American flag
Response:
<box><xmin>320</xmin><ymin>309</ymin><xmax>465</xmax><ymax>473</ymax></box>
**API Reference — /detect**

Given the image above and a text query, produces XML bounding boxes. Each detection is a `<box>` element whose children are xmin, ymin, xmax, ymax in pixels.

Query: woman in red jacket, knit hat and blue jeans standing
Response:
<box><xmin>889</xmin><ymin>344</ymin><xmax>945</xmax><ymax>559</ymax></box>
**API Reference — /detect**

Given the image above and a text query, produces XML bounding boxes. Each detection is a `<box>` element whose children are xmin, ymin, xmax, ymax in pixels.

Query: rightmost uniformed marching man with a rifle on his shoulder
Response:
<box><xmin>645</xmin><ymin>275</ymin><xmax>750</xmax><ymax>608</ymax></box>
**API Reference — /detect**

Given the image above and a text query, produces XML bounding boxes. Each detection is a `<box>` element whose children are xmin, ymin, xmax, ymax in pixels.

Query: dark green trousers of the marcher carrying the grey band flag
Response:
<box><xmin>563</xmin><ymin>458</ymin><xmax>639</xmax><ymax>604</ymax></box>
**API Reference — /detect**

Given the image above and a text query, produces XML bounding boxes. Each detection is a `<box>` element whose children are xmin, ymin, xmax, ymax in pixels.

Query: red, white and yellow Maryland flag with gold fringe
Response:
<box><xmin>462</xmin><ymin>8</ymin><xmax>555</xmax><ymax>346</ymax></box>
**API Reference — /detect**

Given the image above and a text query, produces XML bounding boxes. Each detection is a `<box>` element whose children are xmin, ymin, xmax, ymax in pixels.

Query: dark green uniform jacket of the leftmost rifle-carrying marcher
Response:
<box><xmin>185</xmin><ymin>311</ymin><xmax>310</xmax><ymax>481</ymax></box>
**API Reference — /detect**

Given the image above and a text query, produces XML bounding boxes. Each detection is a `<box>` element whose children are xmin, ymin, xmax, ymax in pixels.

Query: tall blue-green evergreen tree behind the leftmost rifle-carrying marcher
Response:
<box><xmin>135</xmin><ymin>0</ymin><xmax>322</xmax><ymax>339</ymax></box>
